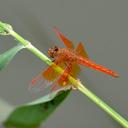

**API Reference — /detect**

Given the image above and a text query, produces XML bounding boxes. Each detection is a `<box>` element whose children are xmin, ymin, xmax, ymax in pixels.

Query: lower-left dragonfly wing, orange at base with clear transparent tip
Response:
<box><xmin>29</xmin><ymin>56</ymin><xmax>64</xmax><ymax>92</ymax></box>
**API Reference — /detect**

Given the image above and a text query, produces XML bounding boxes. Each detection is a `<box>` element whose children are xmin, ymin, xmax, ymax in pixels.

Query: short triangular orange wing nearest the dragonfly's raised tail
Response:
<box><xmin>76</xmin><ymin>42</ymin><xmax>89</xmax><ymax>58</ymax></box>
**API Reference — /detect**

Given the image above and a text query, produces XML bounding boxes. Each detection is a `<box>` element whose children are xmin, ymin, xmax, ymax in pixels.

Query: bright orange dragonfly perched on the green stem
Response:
<box><xmin>31</xmin><ymin>28</ymin><xmax>118</xmax><ymax>90</ymax></box>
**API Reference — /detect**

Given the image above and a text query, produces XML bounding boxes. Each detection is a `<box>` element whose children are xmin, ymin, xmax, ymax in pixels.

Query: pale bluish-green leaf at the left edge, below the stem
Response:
<box><xmin>0</xmin><ymin>44</ymin><xmax>24</xmax><ymax>70</ymax></box>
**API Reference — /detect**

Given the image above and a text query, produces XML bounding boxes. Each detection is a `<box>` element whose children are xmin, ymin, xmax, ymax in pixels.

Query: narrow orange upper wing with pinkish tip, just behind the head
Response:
<box><xmin>54</xmin><ymin>27</ymin><xmax>73</xmax><ymax>49</ymax></box>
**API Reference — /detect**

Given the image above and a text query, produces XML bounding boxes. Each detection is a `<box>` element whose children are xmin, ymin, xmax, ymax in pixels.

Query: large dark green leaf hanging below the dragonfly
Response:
<box><xmin>4</xmin><ymin>90</ymin><xmax>70</xmax><ymax>128</ymax></box>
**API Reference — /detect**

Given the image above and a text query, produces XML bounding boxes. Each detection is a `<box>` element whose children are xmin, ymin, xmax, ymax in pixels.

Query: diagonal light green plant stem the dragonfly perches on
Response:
<box><xmin>0</xmin><ymin>22</ymin><xmax>128</xmax><ymax>128</ymax></box>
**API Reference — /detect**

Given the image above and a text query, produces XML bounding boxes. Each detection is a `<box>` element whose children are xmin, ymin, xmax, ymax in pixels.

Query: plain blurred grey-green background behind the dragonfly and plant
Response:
<box><xmin>0</xmin><ymin>0</ymin><xmax>128</xmax><ymax>128</ymax></box>
